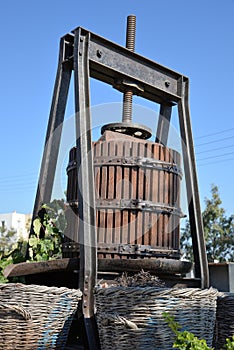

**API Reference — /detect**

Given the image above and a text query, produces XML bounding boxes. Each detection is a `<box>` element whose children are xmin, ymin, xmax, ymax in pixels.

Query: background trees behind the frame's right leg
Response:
<box><xmin>181</xmin><ymin>185</ymin><xmax>234</xmax><ymax>262</ymax></box>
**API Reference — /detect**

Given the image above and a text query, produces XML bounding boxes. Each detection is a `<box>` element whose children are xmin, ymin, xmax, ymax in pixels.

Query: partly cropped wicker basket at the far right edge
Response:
<box><xmin>214</xmin><ymin>293</ymin><xmax>234</xmax><ymax>349</ymax></box>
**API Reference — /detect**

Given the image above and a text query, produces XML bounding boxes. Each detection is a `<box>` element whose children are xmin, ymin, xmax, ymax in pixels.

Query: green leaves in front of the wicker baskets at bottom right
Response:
<box><xmin>162</xmin><ymin>312</ymin><xmax>234</xmax><ymax>350</ymax></box>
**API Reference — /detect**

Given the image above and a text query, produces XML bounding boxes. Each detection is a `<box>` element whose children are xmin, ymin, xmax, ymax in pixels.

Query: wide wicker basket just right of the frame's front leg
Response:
<box><xmin>95</xmin><ymin>287</ymin><xmax>217</xmax><ymax>350</ymax></box>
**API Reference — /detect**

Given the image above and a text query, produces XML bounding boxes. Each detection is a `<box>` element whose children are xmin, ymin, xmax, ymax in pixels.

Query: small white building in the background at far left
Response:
<box><xmin>0</xmin><ymin>211</ymin><xmax>32</xmax><ymax>240</ymax></box>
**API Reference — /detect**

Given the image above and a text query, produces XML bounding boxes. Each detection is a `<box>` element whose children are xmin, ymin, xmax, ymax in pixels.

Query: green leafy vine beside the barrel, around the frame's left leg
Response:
<box><xmin>0</xmin><ymin>200</ymin><xmax>66</xmax><ymax>283</ymax></box>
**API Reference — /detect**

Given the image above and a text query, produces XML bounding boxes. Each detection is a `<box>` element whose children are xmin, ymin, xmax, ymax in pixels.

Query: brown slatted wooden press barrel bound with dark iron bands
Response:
<box><xmin>64</xmin><ymin>132</ymin><xmax>181</xmax><ymax>258</ymax></box>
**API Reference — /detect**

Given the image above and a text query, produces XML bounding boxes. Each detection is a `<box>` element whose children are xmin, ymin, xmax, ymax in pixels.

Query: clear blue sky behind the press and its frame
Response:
<box><xmin>0</xmin><ymin>0</ymin><xmax>234</xmax><ymax>214</ymax></box>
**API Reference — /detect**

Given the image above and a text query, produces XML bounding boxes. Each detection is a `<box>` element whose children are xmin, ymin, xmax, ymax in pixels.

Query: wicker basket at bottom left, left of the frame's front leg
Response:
<box><xmin>0</xmin><ymin>283</ymin><xmax>81</xmax><ymax>350</ymax></box>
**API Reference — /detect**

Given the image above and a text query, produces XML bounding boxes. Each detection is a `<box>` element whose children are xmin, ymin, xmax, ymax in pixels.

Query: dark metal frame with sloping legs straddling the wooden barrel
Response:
<box><xmin>30</xmin><ymin>27</ymin><xmax>209</xmax><ymax>349</ymax></box>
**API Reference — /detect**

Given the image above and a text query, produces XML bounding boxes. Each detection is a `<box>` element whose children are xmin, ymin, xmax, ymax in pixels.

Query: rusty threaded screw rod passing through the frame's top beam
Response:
<box><xmin>122</xmin><ymin>15</ymin><xmax>136</xmax><ymax>123</ymax></box>
